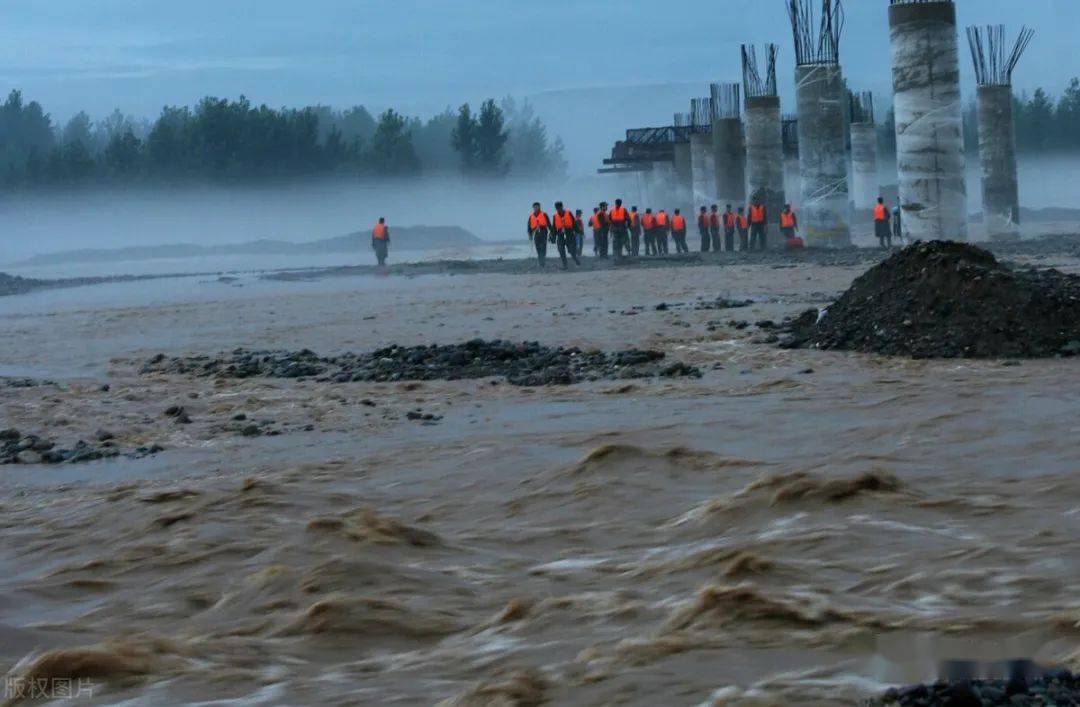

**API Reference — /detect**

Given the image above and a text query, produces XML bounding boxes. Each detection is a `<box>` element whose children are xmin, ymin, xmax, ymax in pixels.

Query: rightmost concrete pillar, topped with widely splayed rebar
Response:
<box><xmin>968</xmin><ymin>25</ymin><xmax>1035</xmax><ymax>241</ymax></box>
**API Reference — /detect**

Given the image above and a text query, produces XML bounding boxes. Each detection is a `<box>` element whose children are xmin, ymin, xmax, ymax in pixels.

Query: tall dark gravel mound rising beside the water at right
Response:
<box><xmin>781</xmin><ymin>241</ymin><xmax>1080</xmax><ymax>358</ymax></box>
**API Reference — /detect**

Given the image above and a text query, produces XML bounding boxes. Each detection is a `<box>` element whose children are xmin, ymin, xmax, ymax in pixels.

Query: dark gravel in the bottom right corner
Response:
<box><xmin>869</xmin><ymin>670</ymin><xmax>1080</xmax><ymax>707</ymax></box>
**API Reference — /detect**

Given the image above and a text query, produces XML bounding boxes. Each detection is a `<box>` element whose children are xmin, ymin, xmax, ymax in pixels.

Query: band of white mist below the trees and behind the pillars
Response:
<box><xmin>6</xmin><ymin>157</ymin><xmax>1080</xmax><ymax>275</ymax></box>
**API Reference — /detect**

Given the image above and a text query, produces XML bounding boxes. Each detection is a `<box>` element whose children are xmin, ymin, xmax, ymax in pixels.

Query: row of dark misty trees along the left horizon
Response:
<box><xmin>0</xmin><ymin>91</ymin><xmax>566</xmax><ymax>187</ymax></box>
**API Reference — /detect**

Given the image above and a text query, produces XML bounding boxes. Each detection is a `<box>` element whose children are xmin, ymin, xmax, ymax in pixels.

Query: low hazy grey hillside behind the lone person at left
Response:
<box><xmin>24</xmin><ymin>226</ymin><xmax>484</xmax><ymax>266</ymax></box>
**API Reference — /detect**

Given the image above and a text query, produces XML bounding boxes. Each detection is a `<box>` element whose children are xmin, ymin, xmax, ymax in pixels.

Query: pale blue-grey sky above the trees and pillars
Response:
<box><xmin>0</xmin><ymin>0</ymin><xmax>1080</xmax><ymax>172</ymax></box>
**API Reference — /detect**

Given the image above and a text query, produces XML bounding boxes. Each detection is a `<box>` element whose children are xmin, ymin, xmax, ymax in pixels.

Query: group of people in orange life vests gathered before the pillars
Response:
<box><xmin>526</xmin><ymin>199</ymin><xmax>801</xmax><ymax>270</ymax></box>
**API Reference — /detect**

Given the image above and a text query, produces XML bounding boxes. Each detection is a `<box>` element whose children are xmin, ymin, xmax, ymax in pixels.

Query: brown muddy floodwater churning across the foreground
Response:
<box><xmin>0</xmin><ymin>254</ymin><xmax>1080</xmax><ymax>705</ymax></box>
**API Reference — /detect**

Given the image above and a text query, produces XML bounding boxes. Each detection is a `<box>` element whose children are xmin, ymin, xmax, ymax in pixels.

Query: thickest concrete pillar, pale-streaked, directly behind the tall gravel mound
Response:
<box><xmin>889</xmin><ymin>0</ymin><xmax>968</xmax><ymax>241</ymax></box>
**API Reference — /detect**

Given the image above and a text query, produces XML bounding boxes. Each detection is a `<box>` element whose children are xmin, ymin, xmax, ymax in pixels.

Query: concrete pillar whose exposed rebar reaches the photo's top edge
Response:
<box><xmin>787</xmin><ymin>0</ymin><xmax>851</xmax><ymax>247</ymax></box>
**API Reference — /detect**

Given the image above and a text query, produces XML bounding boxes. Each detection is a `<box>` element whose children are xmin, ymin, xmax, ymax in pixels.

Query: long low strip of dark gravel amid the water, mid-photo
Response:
<box><xmin>143</xmin><ymin>339</ymin><xmax>701</xmax><ymax>385</ymax></box>
